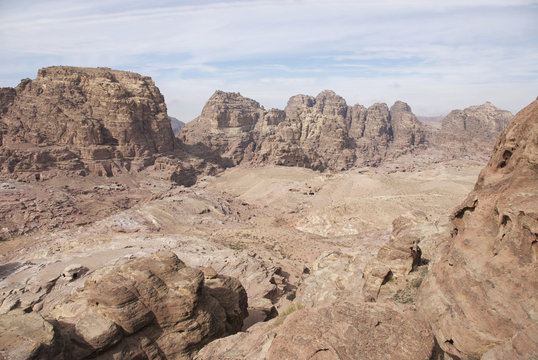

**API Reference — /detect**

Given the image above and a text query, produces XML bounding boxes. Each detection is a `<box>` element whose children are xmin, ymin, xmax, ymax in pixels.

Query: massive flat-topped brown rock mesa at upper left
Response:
<box><xmin>0</xmin><ymin>66</ymin><xmax>174</xmax><ymax>179</ymax></box>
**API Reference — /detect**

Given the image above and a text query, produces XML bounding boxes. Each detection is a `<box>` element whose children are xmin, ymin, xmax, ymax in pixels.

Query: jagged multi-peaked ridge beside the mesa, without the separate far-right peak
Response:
<box><xmin>179</xmin><ymin>90</ymin><xmax>425</xmax><ymax>169</ymax></box>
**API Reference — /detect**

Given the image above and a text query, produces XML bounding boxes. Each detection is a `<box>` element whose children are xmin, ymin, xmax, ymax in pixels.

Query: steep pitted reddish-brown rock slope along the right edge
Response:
<box><xmin>419</xmin><ymin>101</ymin><xmax>538</xmax><ymax>359</ymax></box>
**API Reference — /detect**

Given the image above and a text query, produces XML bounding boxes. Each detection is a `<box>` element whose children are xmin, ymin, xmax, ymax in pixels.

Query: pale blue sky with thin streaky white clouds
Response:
<box><xmin>0</xmin><ymin>0</ymin><xmax>538</xmax><ymax>122</ymax></box>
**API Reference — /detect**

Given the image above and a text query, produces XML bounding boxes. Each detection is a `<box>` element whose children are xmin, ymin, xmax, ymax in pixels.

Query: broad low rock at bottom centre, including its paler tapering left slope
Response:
<box><xmin>196</xmin><ymin>301</ymin><xmax>435</xmax><ymax>360</ymax></box>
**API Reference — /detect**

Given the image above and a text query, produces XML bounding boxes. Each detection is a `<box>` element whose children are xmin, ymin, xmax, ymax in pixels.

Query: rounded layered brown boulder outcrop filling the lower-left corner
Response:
<box><xmin>0</xmin><ymin>252</ymin><xmax>247</xmax><ymax>359</ymax></box>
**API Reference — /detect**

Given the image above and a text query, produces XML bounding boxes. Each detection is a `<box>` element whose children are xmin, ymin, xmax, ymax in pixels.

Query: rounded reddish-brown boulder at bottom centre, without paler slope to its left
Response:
<box><xmin>267</xmin><ymin>301</ymin><xmax>434</xmax><ymax>360</ymax></box>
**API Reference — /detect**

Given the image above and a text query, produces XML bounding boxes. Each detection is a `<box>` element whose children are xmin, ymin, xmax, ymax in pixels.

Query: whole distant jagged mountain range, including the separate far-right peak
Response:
<box><xmin>182</xmin><ymin>90</ymin><xmax>512</xmax><ymax>171</ymax></box>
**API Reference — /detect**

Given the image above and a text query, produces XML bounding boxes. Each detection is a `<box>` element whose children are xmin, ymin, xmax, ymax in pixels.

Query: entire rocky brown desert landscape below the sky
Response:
<box><xmin>0</xmin><ymin>67</ymin><xmax>538</xmax><ymax>359</ymax></box>
